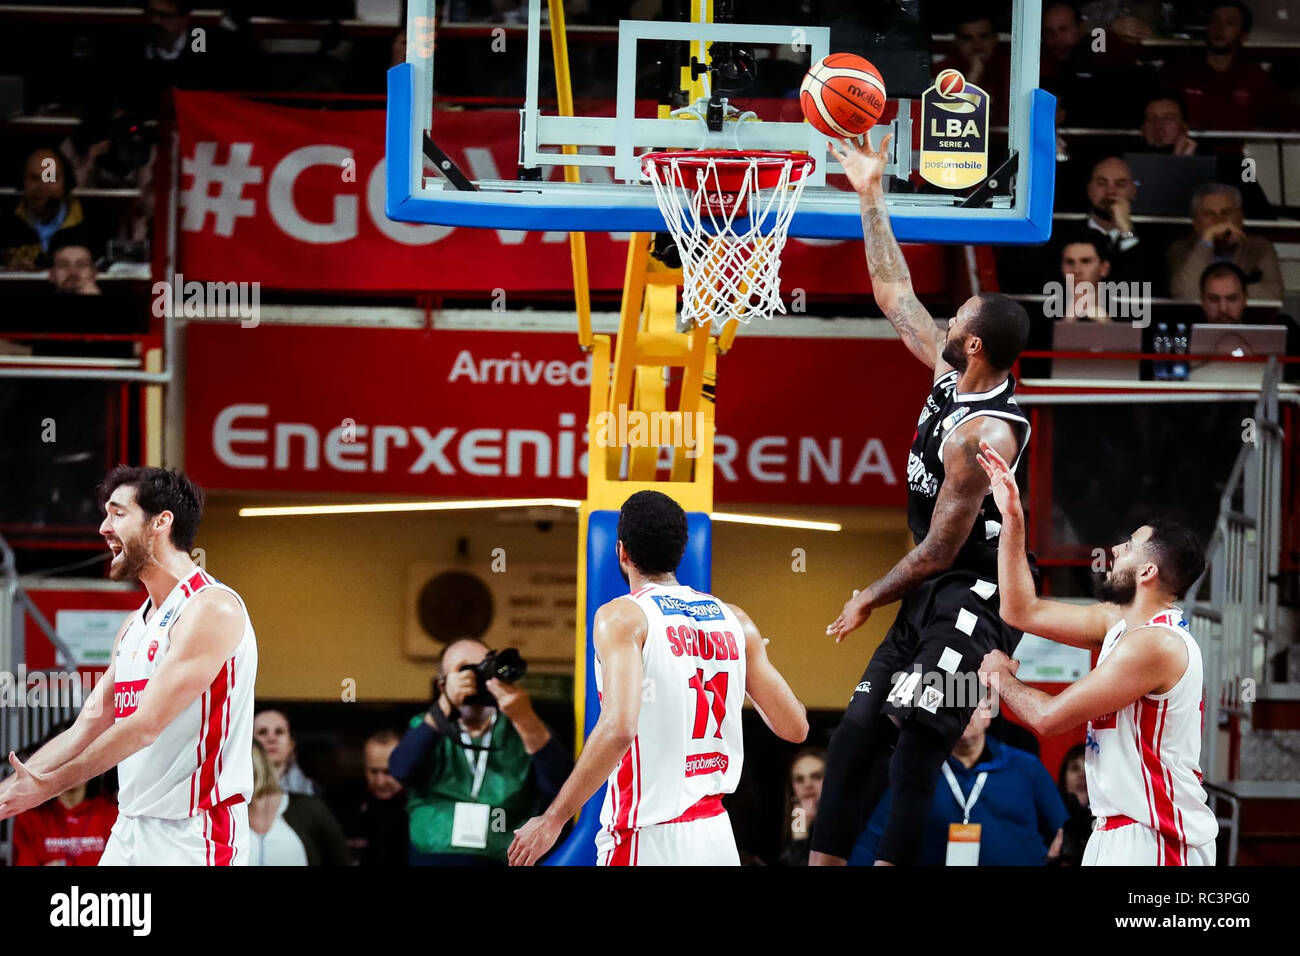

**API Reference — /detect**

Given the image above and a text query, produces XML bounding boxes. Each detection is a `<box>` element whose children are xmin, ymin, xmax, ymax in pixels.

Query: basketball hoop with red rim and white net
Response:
<box><xmin>641</xmin><ymin>150</ymin><xmax>815</xmax><ymax>328</ymax></box>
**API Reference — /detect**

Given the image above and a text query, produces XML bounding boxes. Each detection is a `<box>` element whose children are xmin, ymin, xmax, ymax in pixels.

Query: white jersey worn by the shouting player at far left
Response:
<box><xmin>113</xmin><ymin>568</ymin><xmax>257</xmax><ymax>819</ymax></box>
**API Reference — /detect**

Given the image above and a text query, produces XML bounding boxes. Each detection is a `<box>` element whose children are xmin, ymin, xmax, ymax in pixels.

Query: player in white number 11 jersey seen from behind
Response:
<box><xmin>510</xmin><ymin>492</ymin><xmax>807</xmax><ymax>866</ymax></box>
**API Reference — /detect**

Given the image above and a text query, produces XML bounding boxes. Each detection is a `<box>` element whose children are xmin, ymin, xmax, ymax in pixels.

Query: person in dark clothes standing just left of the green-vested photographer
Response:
<box><xmin>333</xmin><ymin>730</ymin><xmax>411</xmax><ymax>866</ymax></box>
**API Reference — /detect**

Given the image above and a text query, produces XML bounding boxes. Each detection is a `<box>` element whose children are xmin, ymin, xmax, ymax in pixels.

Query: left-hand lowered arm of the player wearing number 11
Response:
<box><xmin>507</xmin><ymin>598</ymin><xmax>649</xmax><ymax>866</ymax></box>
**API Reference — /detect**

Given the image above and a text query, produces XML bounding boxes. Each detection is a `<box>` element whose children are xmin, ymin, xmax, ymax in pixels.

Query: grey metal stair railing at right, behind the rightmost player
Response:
<box><xmin>1188</xmin><ymin>360</ymin><xmax>1284</xmax><ymax>782</ymax></box>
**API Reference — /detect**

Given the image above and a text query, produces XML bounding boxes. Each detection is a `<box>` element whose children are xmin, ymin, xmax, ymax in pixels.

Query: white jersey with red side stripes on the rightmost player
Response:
<box><xmin>1084</xmin><ymin>607</ymin><xmax>1218</xmax><ymax>864</ymax></box>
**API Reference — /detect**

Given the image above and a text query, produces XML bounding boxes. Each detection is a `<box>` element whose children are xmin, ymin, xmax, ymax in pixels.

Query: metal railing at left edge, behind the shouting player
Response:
<box><xmin>0</xmin><ymin>536</ymin><xmax>83</xmax><ymax>865</ymax></box>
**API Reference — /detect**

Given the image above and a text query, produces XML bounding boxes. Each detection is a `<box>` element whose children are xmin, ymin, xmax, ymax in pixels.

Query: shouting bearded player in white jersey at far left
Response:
<box><xmin>0</xmin><ymin>466</ymin><xmax>257</xmax><ymax>866</ymax></box>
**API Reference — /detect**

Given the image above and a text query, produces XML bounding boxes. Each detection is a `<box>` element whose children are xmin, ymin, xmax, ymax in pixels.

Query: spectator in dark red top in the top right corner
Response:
<box><xmin>1162</xmin><ymin>0</ymin><xmax>1300</xmax><ymax>130</ymax></box>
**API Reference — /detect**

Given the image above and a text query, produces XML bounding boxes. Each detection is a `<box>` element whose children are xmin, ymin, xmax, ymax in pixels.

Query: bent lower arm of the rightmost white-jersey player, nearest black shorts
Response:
<box><xmin>979</xmin><ymin>627</ymin><xmax>1187</xmax><ymax>736</ymax></box>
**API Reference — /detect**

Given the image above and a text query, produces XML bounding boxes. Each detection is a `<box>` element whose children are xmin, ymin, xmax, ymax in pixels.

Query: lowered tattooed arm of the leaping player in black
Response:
<box><xmin>826</xmin><ymin>416</ymin><xmax>1017</xmax><ymax>644</ymax></box>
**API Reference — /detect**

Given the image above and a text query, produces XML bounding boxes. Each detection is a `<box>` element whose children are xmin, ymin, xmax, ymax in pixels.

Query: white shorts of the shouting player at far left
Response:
<box><xmin>99</xmin><ymin>804</ymin><xmax>248</xmax><ymax>866</ymax></box>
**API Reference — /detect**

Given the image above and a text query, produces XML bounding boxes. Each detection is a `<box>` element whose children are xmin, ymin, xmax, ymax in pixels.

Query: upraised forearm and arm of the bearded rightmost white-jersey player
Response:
<box><xmin>979</xmin><ymin>441</ymin><xmax>1121</xmax><ymax>648</ymax></box>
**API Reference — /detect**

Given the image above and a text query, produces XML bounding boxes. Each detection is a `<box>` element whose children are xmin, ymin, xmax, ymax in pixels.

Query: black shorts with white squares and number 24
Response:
<box><xmin>844</xmin><ymin>570</ymin><xmax>1021</xmax><ymax>747</ymax></box>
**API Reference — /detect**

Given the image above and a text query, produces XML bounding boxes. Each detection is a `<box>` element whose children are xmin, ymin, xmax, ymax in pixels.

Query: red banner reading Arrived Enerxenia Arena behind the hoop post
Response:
<box><xmin>186</xmin><ymin>324</ymin><xmax>930</xmax><ymax>506</ymax></box>
